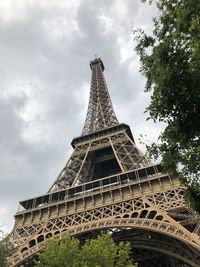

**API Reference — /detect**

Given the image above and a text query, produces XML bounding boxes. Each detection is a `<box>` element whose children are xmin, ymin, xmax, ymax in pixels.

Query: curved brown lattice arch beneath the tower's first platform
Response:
<box><xmin>7</xmin><ymin>189</ymin><xmax>200</xmax><ymax>267</ymax></box>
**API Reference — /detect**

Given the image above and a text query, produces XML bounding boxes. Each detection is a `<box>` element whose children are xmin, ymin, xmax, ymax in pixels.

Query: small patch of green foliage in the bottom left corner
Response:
<box><xmin>0</xmin><ymin>230</ymin><xmax>13</xmax><ymax>267</ymax></box>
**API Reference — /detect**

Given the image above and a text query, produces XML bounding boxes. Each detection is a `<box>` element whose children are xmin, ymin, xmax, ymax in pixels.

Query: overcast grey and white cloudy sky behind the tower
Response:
<box><xmin>0</xmin><ymin>0</ymin><xmax>161</xmax><ymax>231</ymax></box>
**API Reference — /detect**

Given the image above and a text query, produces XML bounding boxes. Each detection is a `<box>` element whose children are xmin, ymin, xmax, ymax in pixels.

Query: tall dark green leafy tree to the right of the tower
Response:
<box><xmin>134</xmin><ymin>0</ymin><xmax>200</xmax><ymax>211</ymax></box>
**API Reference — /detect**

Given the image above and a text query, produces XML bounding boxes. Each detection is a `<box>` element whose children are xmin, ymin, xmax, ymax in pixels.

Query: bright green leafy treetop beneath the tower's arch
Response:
<box><xmin>35</xmin><ymin>234</ymin><xmax>135</xmax><ymax>267</ymax></box>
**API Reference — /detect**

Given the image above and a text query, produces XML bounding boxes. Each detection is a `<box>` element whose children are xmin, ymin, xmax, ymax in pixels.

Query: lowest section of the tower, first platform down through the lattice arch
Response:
<box><xmin>9</xmin><ymin>175</ymin><xmax>200</xmax><ymax>267</ymax></box>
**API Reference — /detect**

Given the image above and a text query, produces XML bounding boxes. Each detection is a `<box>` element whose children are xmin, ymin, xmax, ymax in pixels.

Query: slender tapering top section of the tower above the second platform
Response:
<box><xmin>82</xmin><ymin>58</ymin><xmax>119</xmax><ymax>135</ymax></box>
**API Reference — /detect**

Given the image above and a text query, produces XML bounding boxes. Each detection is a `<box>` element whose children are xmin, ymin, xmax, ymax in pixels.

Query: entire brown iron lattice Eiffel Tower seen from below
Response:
<box><xmin>8</xmin><ymin>58</ymin><xmax>200</xmax><ymax>267</ymax></box>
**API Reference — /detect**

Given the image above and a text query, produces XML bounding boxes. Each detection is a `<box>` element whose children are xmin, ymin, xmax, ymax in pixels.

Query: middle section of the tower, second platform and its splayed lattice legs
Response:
<box><xmin>49</xmin><ymin>124</ymin><xmax>151</xmax><ymax>192</ymax></box>
